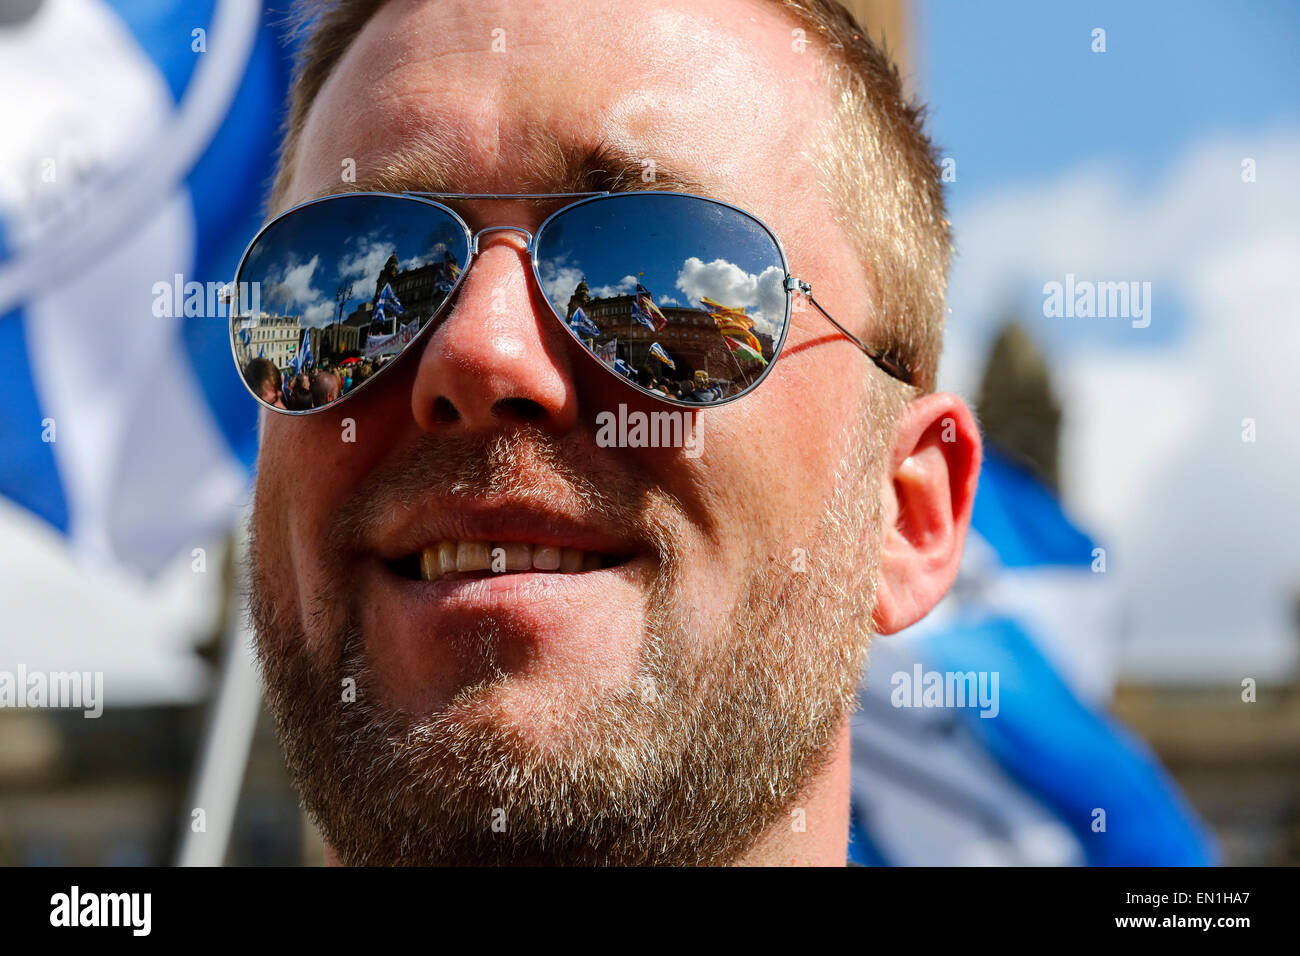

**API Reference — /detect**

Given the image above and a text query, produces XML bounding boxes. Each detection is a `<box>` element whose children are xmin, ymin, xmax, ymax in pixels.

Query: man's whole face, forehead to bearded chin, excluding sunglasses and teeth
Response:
<box><xmin>252</xmin><ymin>0</ymin><xmax>897</xmax><ymax>862</ymax></box>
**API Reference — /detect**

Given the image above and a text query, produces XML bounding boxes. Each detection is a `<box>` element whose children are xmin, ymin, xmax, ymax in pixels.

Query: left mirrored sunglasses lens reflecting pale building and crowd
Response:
<box><xmin>230</xmin><ymin>194</ymin><xmax>469</xmax><ymax>411</ymax></box>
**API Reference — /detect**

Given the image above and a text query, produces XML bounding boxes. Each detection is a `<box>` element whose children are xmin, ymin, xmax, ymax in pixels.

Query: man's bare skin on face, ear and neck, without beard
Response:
<box><xmin>257</xmin><ymin>0</ymin><xmax>980</xmax><ymax>865</ymax></box>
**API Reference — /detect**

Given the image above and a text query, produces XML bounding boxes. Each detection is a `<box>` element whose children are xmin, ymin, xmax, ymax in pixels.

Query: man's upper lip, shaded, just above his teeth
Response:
<box><xmin>372</xmin><ymin>498</ymin><xmax>641</xmax><ymax>561</ymax></box>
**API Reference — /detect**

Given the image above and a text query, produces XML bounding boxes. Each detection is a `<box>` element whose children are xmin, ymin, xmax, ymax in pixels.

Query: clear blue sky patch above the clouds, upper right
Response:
<box><xmin>913</xmin><ymin>0</ymin><xmax>1300</xmax><ymax>196</ymax></box>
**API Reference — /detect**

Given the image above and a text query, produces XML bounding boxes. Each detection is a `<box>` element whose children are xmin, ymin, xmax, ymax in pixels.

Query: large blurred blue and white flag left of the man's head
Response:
<box><xmin>0</xmin><ymin>0</ymin><xmax>290</xmax><ymax>574</ymax></box>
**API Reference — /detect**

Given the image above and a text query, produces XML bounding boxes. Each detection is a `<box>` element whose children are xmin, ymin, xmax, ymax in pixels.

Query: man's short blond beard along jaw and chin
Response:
<box><xmin>250</xmin><ymin>389</ymin><xmax>901</xmax><ymax>865</ymax></box>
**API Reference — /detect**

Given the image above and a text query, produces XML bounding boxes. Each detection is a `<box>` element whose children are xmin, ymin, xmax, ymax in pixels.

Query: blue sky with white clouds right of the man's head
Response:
<box><xmin>911</xmin><ymin>0</ymin><xmax>1300</xmax><ymax>680</ymax></box>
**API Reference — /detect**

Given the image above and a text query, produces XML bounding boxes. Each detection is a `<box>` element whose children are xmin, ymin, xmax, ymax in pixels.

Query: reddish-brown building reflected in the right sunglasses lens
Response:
<box><xmin>566</xmin><ymin>291</ymin><xmax>772</xmax><ymax>384</ymax></box>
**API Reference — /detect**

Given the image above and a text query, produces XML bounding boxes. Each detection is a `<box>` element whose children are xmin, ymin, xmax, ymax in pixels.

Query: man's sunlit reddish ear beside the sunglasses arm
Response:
<box><xmin>875</xmin><ymin>392</ymin><xmax>982</xmax><ymax>633</ymax></box>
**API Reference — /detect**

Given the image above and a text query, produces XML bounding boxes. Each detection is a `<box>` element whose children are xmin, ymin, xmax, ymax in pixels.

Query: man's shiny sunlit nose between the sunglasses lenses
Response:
<box><xmin>411</xmin><ymin>226</ymin><xmax>577</xmax><ymax>433</ymax></box>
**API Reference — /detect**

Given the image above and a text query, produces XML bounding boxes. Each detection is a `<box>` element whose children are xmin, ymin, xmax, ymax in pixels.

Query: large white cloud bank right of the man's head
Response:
<box><xmin>943</xmin><ymin>130</ymin><xmax>1300</xmax><ymax>679</ymax></box>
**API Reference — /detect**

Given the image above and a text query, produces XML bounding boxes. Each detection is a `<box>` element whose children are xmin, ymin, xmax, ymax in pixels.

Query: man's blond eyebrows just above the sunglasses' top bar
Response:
<box><xmin>317</xmin><ymin>134</ymin><xmax>716</xmax><ymax>196</ymax></box>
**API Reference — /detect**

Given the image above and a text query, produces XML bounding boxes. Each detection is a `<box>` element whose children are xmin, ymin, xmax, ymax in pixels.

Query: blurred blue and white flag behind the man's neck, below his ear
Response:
<box><xmin>849</xmin><ymin>447</ymin><xmax>1217</xmax><ymax>866</ymax></box>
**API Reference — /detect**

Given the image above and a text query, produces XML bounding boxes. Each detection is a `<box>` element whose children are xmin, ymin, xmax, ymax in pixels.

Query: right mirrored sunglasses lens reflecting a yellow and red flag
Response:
<box><xmin>537</xmin><ymin>193</ymin><xmax>789</xmax><ymax>405</ymax></box>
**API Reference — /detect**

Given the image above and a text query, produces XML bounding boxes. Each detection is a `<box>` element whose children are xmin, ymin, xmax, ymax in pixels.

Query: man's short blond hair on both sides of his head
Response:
<box><xmin>270</xmin><ymin>0</ymin><xmax>952</xmax><ymax>392</ymax></box>
